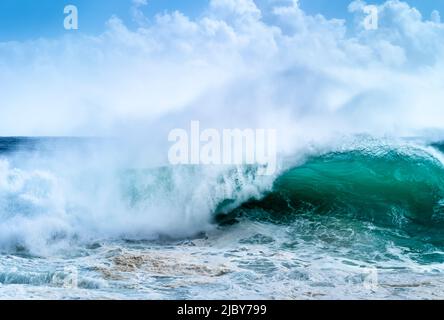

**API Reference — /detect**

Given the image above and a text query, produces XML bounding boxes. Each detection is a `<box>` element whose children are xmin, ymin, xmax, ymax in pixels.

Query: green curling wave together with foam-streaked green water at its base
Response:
<box><xmin>217</xmin><ymin>147</ymin><xmax>444</xmax><ymax>263</ymax></box>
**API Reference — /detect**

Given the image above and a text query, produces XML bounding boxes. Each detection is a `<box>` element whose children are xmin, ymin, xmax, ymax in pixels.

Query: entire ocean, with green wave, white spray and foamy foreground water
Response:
<box><xmin>0</xmin><ymin>138</ymin><xmax>444</xmax><ymax>299</ymax></box>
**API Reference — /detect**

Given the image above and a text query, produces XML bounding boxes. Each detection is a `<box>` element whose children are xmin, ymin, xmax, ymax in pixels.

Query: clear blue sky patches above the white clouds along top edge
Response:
<box><xmin>0</xmin><ymin>0</ymin><xmax>444</xmax><ymax>41</ymax></box>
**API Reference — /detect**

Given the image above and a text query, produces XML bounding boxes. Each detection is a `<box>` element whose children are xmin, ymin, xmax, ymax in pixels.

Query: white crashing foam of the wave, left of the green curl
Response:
<box><xmin>0</xmin><ymin>151</ymin><xmax>274</xmax><ymax>254</ymax></box>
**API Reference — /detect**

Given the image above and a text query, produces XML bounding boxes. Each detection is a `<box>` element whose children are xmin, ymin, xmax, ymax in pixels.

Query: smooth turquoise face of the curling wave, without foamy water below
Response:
<box><xmin>219</xmin><ymin>147</ymin><xmax>444</xmax><ymax>249</ymax></box>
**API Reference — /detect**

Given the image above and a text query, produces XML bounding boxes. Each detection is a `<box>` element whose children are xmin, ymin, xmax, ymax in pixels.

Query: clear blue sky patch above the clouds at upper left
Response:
<box><xmin>0</xmin><ymin>0</ymin><xmax>207</xmax><ymax>41</ymax></box>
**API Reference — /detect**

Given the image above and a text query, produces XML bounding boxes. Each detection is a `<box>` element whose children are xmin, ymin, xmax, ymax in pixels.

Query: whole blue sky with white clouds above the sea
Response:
<box><xmin>0</xmin><ymin>0</ymin><xmax>444</xmax><ymax>138</ymax></box>
